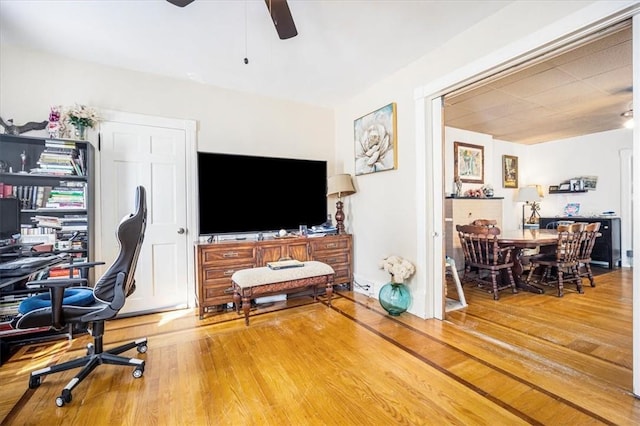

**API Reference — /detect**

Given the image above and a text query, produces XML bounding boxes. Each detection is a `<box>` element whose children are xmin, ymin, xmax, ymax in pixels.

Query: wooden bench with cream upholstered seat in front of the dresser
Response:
<box><xmin>231</xmin><ymin>260</ymin><xmax>335</xmax><ymax>325</ymax></box>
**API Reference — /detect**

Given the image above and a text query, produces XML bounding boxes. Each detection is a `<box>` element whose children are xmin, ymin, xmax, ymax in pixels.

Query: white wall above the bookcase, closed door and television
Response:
<box><xmin>0</xmin><ymin>45</ymin><xmax>335</xmax><ymax>167</ymax></box>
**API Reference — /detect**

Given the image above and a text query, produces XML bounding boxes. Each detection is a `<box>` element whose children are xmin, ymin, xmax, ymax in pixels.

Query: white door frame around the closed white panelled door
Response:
<box><xmin>95</xmin><ymin>109</ymin><xmax>198</xmax><ymax>308</ymax></box>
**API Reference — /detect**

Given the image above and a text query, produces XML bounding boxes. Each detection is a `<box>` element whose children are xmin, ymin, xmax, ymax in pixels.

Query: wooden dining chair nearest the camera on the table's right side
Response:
<box><xmin>527</xmin><ymin>230</ymin><xmax>584</xmax><ymax>297</ymax></box>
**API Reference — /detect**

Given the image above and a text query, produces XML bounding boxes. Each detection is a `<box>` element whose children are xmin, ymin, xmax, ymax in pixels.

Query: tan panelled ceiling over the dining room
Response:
<box><xmin>444</xmin><ymin>23</ymin><xmax>633</xmax><ymax>145</ymax></box>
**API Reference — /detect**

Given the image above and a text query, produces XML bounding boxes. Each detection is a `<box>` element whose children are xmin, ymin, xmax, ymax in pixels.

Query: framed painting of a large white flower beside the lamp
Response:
<box><xmin>353</xmin><ymin>103</ymin><xmax>398</xmax><ymax>176</ymax></box>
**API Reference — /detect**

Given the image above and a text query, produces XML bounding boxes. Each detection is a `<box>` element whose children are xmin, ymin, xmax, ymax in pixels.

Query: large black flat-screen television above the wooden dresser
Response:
<box><xmin>198</xmin><ymin>152</ymin><xmax>327</xmax><ymax>235</ymax></box>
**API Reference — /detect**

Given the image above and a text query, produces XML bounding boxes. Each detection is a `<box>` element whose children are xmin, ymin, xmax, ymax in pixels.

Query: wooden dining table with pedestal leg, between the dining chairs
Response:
<box><xmin>498</xmin><ymin>229</ymin><xmax>558</xmax><ymax>294</ymax></box>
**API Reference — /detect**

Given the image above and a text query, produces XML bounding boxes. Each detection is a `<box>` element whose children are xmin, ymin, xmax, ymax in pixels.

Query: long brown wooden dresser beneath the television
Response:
<box><xmin>195</xmin><ymin>234</ymin><xmax>353</xmax><ymax>319</ymax></box>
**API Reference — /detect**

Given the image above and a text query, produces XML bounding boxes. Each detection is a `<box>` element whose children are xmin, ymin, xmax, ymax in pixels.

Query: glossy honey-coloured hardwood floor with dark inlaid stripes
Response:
<box><xmin>0</xmin><ymin>269</ymin><xmax>640</xmax><ymax>425</ymax></box>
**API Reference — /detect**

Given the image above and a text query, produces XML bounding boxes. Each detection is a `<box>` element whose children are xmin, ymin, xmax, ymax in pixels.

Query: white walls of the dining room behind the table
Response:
<box><xmin>444</xmin><ymin>127</ymin><xmax>633</xmax><ymax>235</ymax></box>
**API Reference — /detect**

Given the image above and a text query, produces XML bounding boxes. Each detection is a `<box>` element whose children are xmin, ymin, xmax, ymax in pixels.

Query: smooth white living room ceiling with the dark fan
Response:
<box><xmin>0</xmin><ymin>0</ymin><xmax>512</xmax><ymax>107</ymax></box>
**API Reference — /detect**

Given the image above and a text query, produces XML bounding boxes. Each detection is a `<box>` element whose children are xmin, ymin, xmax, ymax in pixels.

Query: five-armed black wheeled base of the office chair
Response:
<box><xmin>29</xmin><ymin>326</ymin><xmax>148</xmax><ymax>407</ymax></box>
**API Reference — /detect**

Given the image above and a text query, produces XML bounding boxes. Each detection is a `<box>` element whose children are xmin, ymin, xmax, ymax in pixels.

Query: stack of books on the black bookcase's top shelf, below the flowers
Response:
<box><xmin>31</xmin><ymin>140</ymin><xmax>86</xmax><ymax>176</ymax></box>
